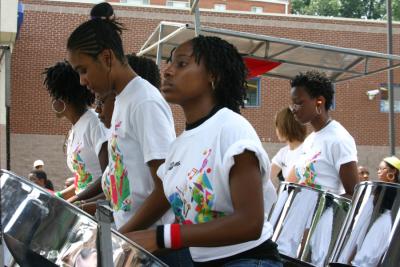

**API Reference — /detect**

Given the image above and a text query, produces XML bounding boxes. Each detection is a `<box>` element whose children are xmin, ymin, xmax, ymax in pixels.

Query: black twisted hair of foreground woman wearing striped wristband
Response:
<box><xmin>191</xmin><ymin>35</ymin><xmax>247</xmax><ymax>113</ymax></box>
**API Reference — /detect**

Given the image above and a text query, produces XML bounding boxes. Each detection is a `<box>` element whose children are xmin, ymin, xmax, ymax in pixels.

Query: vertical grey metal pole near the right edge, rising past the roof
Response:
<box><xmin>386</xmin><ymin>0</ymin><xmax>396</xmax><ymax>155</ymax></box>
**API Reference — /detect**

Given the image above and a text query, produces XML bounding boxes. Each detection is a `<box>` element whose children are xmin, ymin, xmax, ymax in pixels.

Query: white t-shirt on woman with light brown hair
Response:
<box><xmin>271</xmin><ymin>145</ymin><xmax>303</xmax><ymax>179</ymax></box>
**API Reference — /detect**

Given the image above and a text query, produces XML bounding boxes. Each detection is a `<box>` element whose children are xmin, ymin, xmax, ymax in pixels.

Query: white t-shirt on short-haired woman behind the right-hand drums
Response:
<box><xmin>295</xmin><ymin>120</ymin><xmax>357</xmax><ymax>194</ymax></box>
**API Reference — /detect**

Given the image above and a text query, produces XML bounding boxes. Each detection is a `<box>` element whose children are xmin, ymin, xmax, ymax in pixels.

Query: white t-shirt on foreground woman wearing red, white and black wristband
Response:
<box><xmin>157</xmin><ymin>108</ymin><xmax>276</xmax><ymax>262</ymax></box>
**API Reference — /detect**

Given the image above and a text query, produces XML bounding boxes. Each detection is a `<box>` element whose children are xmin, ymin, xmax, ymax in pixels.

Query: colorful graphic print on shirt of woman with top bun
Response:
<box><xmin>105</xmin><ymin>122</ymin><xmax>132</xmax><ymax>211</ymax></box>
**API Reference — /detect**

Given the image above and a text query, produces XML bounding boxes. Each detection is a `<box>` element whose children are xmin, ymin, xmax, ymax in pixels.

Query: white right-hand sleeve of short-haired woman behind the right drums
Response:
<box><xmin>332</xmin><ymin>136</ymin><xmax>357</xmax><ymax>172</ymax></box>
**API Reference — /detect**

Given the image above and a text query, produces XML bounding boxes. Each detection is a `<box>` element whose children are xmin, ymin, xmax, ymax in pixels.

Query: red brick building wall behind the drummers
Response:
<box><xmin>1</xmin><ymin>0</ymin><xmax>400</xmax><ymax>189</ymax></box>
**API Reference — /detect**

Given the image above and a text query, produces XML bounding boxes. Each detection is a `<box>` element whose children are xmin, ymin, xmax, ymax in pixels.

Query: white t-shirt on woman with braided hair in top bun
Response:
<box><xmin>105</xmin><ymin>76</ymin><xmax>175</xmax><ymax>228</ymax></box>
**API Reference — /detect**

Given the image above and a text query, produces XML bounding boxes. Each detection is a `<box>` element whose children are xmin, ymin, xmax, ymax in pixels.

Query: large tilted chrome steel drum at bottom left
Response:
<box><xmin>0</xmin><ymin>170</ymin><xmax>166</xmax><ymax>267</ymax></box>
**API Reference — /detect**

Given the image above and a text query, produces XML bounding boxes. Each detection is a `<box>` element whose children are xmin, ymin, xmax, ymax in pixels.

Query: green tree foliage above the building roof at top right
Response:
<box><xmin>291</xmin><ymin>0</ymin><xmax>400</xmax><ymax>20</ymax></box>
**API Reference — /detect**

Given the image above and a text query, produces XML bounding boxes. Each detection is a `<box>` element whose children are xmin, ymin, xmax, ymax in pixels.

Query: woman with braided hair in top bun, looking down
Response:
<box><xmin>67</xmin><ymin>3</ymin><xmax>175</xmax><ymax>233</ymax></box>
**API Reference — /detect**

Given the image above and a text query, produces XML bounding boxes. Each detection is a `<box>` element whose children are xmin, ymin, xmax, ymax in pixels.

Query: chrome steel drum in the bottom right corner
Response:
<box><xmin>330</xmin><ymin>182</ymin><xmax>400</xmax><ymax>267</ymax></box>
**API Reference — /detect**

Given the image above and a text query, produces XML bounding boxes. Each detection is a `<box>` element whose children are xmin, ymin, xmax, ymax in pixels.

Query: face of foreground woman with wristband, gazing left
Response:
<box><xmin>161</xmin><ymin>41</ymin><xmax>213</xmax><ymax>106</ymax></box>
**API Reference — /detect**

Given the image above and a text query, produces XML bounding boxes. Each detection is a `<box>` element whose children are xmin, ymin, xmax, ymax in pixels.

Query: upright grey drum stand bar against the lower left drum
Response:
<box><xmin>96</xmin><ymin>200</ymin><xmax>114</xmax><ymax>267</ymax></box>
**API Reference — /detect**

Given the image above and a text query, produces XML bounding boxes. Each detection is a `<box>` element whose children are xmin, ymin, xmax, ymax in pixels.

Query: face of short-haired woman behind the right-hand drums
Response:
<box><xmin>290</xmin><ymin>86</ymin><xmax>323</xmax><ymax>124</ymax></box>
